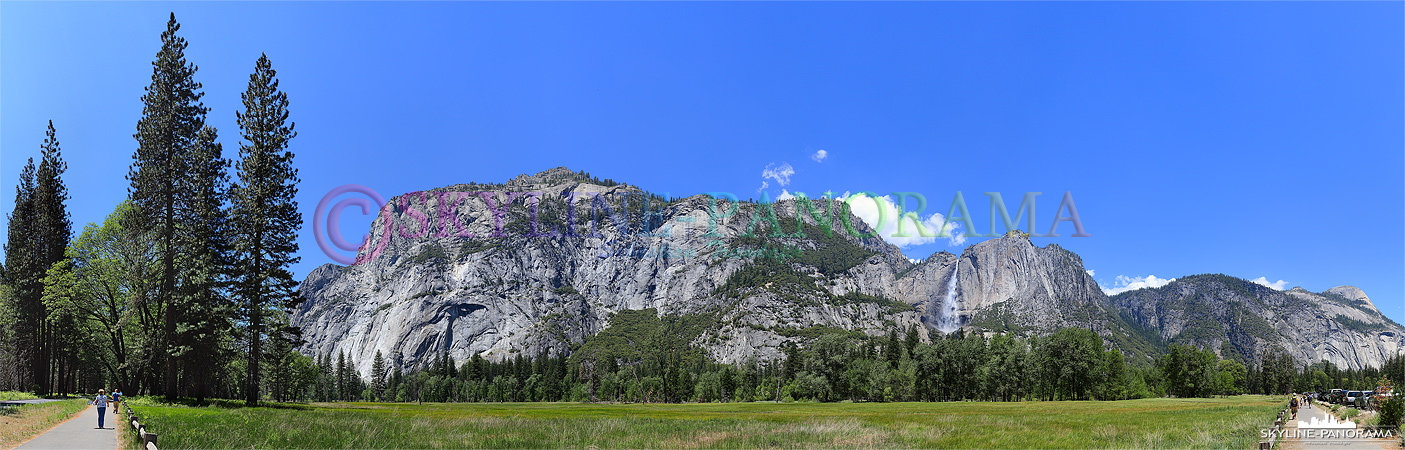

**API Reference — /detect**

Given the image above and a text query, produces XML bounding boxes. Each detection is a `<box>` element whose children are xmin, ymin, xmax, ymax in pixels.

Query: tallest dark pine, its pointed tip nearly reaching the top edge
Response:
<box><xmin>128</xmin><ymin>13</ymin><xmax>209</xmax><ymax>398</ymax></box>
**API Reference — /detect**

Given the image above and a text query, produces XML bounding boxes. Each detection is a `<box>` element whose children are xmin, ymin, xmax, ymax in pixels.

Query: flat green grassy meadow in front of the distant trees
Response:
<box><xmin>128</xmin><ymin>395</ymin><xmax>1284</xmax><ymax>450</ymax></box>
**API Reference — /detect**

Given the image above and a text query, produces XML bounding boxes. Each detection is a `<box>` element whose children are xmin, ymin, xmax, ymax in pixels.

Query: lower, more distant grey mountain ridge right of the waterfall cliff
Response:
<box><xmin>1111</xmin><ymin>274</ymin><xmax>1405</xmax><ymax>368</ymax></box>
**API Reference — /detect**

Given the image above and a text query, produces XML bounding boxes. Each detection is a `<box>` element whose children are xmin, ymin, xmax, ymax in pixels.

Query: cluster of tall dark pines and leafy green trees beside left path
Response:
<box><xmin>0</xmin><ymin>14</ymin><xmax>302</xmax><ymax>404</ymax></box>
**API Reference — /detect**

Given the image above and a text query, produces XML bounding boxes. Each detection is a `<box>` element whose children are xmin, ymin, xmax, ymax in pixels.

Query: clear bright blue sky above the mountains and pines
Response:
<box><xmin>0</xmin><ymin>1</ymin><xmax>1405</xmax><ymax>322</ymax></box>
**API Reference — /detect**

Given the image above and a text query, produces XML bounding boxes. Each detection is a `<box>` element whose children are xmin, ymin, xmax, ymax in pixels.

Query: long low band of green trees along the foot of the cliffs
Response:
<box><xmin>288</xmin><ymin>309</ymin><xmax>1405</xmax><ymax>402</ymax></box>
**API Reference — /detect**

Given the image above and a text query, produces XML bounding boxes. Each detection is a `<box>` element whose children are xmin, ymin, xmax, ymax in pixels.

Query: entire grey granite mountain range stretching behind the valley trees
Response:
<box><xmin>291</xmin><ymin>167</ymin><xmax>1402</xmax><ymax>374</ymax></box>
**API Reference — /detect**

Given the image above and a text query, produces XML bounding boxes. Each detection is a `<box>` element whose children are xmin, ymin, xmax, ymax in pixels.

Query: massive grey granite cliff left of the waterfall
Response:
<box><xmin>292</xmin><ymin>167</ymin><xmax>920</xmax><ymax>373</ymax></box>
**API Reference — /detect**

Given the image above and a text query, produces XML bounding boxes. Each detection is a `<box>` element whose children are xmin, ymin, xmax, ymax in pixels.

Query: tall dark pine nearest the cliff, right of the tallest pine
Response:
<box><xmin>229</xmin><ymin>55</ymin><xmax>302</xmax><ymax>405</ymax></box>
